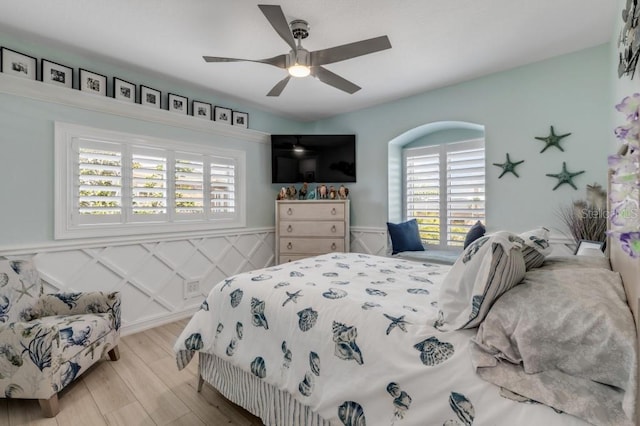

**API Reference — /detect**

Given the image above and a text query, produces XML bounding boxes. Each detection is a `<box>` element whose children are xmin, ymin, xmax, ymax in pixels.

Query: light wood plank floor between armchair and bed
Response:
<box><xmin>0</xmin><ymin>320</ymin><xmax>262</xmax><ymax>426</ymax></box>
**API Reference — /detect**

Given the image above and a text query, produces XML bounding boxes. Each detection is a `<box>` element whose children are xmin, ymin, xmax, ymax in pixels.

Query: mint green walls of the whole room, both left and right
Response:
<box><xmin>0</xmin><ymin>27</ymin><xmax>622</xmax><ymax>246</ymax></box>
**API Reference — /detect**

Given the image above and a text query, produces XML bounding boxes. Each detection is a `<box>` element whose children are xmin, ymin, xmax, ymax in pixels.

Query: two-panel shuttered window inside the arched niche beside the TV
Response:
<box><xmin>404</xmin><ymin>140</ymin><xmax>485</xmax><ymax>248</ymax></box>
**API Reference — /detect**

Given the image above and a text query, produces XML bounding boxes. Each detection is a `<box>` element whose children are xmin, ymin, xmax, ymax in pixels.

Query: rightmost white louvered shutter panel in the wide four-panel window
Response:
<box><xmin>209</xmin><ymin>158</ymin><xmax>237</xmax><ymax>215</ymax></box>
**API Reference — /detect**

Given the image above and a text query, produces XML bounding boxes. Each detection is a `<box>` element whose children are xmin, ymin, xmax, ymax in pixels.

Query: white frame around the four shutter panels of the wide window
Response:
<box><xmin>54</xmin><ymin>122</ymin><xmax>246</xmax><ymax>239</ymax></box>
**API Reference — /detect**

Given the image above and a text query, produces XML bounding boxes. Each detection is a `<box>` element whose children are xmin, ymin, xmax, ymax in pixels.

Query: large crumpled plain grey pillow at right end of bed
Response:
<box><xmin>471</xmin><ymin>267</ymin><xmax>637</xmax><ymax>425</ymax></box>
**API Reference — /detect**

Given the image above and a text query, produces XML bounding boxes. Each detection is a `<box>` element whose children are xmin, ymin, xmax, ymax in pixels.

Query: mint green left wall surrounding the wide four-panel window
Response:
<box><xmin>0</xmin><ymin>32</ymin><xmax>305</xmax><ymax>247</ymax></box>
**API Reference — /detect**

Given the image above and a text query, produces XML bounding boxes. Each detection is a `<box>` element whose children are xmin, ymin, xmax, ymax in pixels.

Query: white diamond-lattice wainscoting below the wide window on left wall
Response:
<box><xmin>0</xmin><ymin>229</ymin><xmax>275</xmax><ymax>335</ymax></box>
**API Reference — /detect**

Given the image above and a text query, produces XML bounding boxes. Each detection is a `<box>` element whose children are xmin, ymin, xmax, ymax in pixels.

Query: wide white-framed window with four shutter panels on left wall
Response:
<box><xmin>55</xmin><ymin>123</ymin><xmax>246</xmax><ymax>239</ymax></box>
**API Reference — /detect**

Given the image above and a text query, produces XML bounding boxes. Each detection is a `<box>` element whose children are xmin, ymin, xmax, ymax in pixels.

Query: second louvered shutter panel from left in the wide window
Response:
<box><xmin>131</xmin><ymin>147</ymin><xmax>168</xmax><ymax>220</ymax></box>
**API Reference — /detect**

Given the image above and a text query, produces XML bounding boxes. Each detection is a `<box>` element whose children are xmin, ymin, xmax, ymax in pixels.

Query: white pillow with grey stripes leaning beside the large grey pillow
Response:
<box><xmin>435</xmin><ymin>231</ymin><xmax>525</xmax><ymax>330</ymax></box>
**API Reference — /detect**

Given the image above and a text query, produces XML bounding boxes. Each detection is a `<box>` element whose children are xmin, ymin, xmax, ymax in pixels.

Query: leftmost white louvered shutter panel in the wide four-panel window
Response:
<box><xmin>73</xmin><ymin>139</ymin><xmax>123</xmax><ymax>223</ymax></box>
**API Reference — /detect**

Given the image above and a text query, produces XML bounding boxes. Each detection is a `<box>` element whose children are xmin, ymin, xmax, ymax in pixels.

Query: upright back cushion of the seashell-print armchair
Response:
<box><xmin>0</xmin><ymin>260</ymin><xmax>42</xmax><ymax>323</ymax></box>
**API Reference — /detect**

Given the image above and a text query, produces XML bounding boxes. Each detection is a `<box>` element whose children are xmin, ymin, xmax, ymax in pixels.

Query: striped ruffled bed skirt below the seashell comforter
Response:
<box><xmin>198</xmin><ymin>352</ymin><xmax>331</xmax><ymax>426</ymax></box>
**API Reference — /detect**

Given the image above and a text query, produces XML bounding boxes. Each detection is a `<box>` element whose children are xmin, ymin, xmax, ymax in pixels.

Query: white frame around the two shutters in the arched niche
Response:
<box><xmin>402</xmin><ymin>139</ymin><xmax>487</xmax><ymax>249</ymax></box>
